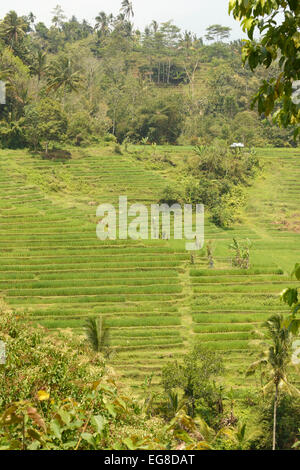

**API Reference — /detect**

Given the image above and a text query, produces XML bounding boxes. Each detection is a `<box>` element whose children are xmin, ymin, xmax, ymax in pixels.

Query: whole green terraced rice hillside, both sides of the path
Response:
<box><xmin>0</xmin><ymin>147</ymin><xmax>300</xmax><ymax>386</ymax></box>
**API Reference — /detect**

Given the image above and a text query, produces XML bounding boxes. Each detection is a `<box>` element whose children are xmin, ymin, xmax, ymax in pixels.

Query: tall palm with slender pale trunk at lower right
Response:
<box><xmin>246</xmin><ymin>314</ymin><xmax>300</xmax><ymax>450</ymax></box>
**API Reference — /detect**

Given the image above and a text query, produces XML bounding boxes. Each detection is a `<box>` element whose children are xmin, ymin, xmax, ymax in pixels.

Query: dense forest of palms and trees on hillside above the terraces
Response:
<box><xmin>0</xmin><ymin>5</ymin><xmax>294</xmax><ymax>149</ymax></box>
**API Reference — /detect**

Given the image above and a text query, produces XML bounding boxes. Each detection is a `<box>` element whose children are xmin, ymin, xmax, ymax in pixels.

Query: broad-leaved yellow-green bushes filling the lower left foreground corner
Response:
<box><xmin>0</xmin><ymin>307</ymin><xmax>237</xmax><ymax>450</ymax></box>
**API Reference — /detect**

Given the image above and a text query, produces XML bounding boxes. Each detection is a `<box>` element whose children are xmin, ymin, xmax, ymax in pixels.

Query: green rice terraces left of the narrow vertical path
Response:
<box><xmin>0</xmin><ymin>149</ymin><xmax>188</xmax><ymax>386</ymax></box>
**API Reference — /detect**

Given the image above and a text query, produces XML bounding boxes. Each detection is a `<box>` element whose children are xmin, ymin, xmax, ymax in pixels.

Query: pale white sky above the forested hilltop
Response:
<box><xmin>0</xmin><ymin>0</ymin><xmax>244</xmax><ymax>39</ymax></box>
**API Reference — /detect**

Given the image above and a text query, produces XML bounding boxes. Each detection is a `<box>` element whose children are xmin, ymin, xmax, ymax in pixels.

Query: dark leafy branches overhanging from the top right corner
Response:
<box><xmin>229</xmin><ymin>0</ymin><xmax>300</xmax><ymax>136</ymax></box>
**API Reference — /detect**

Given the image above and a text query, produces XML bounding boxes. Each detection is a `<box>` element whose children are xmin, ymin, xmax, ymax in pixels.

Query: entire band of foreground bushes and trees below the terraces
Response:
<box><xmin>0</xmin><ymin>276</ymin><xmax>300</xmax><ymax>450</ymax></box>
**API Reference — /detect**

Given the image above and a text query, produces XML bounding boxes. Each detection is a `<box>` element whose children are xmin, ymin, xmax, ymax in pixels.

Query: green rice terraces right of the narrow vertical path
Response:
<box><xmin>190</xmin><ymin>149</ymin><xmax>300</xmax><ymax>386</ymax></box>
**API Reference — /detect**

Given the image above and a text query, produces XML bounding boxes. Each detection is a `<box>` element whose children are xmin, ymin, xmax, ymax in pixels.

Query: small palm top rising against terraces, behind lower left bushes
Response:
<box><xmin>85</xmin><ymin>316</ymin><xmax>110</xmax><ymax>356</ymax></box>
